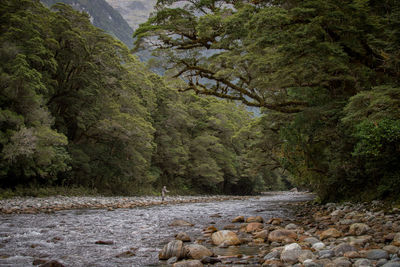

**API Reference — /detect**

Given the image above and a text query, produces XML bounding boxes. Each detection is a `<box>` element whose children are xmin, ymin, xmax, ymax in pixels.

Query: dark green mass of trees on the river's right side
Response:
<box><xmin>134</xmin><ymin>0</ymin><xmax>400</xmax><ymax>200</ymax></box>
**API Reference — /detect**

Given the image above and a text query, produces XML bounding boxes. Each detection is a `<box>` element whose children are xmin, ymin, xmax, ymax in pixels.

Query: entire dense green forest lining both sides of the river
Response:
<box><xmin>0</xmin><ymin>0</ymin><xmax>400</xmax><ymax>201</ymax></box>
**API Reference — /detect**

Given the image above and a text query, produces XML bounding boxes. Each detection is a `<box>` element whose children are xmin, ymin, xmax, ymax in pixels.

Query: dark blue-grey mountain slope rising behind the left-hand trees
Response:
<box><xmin>42</xmin><ymin>0</ymin><xmax>133</xmax><ymax>47</ymax></box>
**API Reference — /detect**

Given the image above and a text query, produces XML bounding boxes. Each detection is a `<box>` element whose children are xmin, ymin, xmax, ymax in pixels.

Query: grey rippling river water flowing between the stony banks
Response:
<box><xmin>0</xmin><ymin>193</ymin><xmax>310</xmax><ymax>267</ymax></box>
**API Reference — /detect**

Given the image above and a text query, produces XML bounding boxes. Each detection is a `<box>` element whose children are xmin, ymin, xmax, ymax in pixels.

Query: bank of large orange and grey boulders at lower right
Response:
<box><xmin>160</xmin><ymin>196</ymin><xmax>400</xmax><ymax>267</ymax></box>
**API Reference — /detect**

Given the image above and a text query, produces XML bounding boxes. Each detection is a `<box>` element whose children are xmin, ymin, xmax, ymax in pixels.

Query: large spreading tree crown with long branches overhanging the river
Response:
<box><xmin>135</xmin><ymin>0</ymin><xmax>388</xmax><ymax>113</ymax></box>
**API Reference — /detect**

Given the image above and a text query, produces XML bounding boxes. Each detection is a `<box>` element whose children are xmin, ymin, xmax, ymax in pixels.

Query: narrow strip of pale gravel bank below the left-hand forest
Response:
<box><xmin>0</xmin><ymin>196</ymin><xmax>254</xmax><ymax>214</ymax></box>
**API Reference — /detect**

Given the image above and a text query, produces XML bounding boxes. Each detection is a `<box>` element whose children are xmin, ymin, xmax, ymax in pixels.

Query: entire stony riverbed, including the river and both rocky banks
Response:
<box><xmin>0</xmin><ymin>192</ymin><xmax>400</xmax><ymax>267</ymax></box>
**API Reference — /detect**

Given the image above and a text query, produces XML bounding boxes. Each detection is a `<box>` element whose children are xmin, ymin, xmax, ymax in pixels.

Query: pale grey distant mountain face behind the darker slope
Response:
<box><xmin>106</xmin><ymin>0</ymin><xmax>157</xmax><ymax>30</ymax></box>
